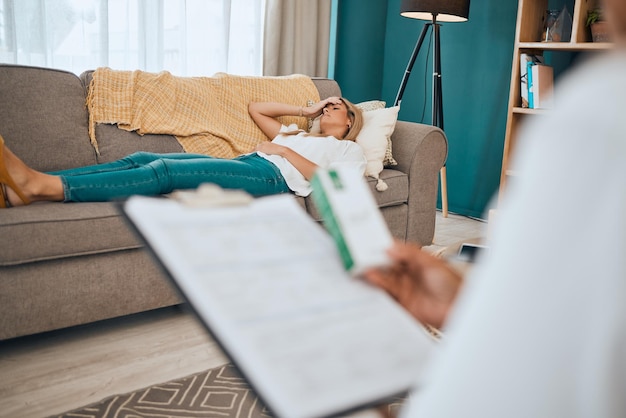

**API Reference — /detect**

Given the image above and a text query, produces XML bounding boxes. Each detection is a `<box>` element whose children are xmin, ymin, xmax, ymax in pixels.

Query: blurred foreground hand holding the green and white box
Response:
<box><xmin>364</xmin><ymin>241</ymin><xmax>463</xmax><ymax>328</ymax></box>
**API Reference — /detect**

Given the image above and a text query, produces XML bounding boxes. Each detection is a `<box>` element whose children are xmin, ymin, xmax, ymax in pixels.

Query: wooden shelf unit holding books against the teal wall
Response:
<box><xmin>499</xmin><ymin>0</ymin><xmax>613</xmax><ymax>197</ymax></box>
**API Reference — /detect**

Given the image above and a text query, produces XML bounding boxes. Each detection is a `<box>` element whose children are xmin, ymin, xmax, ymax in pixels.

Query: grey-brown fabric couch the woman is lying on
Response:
<box><xmin>0</xmin><ymin>65</ymin><xmax>447</xmax><ymax>340</ymax></box>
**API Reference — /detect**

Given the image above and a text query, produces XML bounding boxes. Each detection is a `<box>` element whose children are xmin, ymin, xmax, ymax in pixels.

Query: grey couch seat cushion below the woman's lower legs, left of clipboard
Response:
<box><xmin>0</xmin><ymin>202</ymin><xmax>142</xmax><ymax>266</ymax></box>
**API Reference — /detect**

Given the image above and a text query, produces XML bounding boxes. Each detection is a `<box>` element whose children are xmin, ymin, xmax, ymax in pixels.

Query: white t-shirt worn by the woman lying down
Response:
<box><xmin>257</xmin><ymin>124</ymin><xmax>367</xmax><ymax>196</ymax></box>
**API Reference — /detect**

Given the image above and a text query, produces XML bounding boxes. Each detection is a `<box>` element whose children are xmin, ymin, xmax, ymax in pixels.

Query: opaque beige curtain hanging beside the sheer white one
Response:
<box><xmin>263</xmin><ymin>0</ymin><xmax>331</xmax><ymax>77</ymax></box>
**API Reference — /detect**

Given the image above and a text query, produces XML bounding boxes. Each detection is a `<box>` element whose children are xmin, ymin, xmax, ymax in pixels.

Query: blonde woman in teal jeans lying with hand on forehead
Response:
<box><xmin>0</xmin><ymin>97</ymin><xmax>366</xmax><ymax>207</ymax></box>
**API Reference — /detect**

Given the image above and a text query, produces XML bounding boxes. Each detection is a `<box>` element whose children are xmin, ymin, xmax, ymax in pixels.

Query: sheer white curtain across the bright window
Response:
<box><xmin>0</xmin><ymin>0</ymin><xmax>265</xmax><ymax>76</ymax></box>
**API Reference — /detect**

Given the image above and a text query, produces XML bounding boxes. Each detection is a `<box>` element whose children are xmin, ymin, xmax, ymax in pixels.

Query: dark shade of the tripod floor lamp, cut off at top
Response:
<box><xmin>400</xmin><ymin>0</ymin><xmax>470</xmax><ymax>22</ymax></box>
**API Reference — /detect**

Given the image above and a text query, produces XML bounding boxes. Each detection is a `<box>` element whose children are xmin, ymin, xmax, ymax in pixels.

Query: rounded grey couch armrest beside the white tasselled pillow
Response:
<box><xmin>391</xmin><ymin>121</ymin><xmax>448</xmax><ymax>245</ymax></box>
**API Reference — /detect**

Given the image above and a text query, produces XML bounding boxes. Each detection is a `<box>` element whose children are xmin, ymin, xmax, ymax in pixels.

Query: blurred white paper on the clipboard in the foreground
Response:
<box><xmin>122</xmin><ymin>168</ymin><xmax>437</xmax><ymax>418</ymax></box>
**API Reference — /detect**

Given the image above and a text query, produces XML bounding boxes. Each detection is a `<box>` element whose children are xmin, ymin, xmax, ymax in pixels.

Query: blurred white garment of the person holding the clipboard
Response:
<box><xmin>403</xmin><ymin>50</ymin><xmax>626</xmax><ymax>418</ymax></box>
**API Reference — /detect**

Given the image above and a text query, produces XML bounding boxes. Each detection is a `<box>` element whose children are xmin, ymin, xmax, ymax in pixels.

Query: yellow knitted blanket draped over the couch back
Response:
<box><xmin>87</xmin><ymin>68</ymin><xmax>319</xmax><ymax>158</ymax></box>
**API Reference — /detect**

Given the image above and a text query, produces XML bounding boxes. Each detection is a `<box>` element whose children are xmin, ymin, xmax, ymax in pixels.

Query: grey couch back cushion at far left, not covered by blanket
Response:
<box><xmin>0</xmin><ymin>64</ymin><xmax>96</xmax><ymax>171</ymax></box>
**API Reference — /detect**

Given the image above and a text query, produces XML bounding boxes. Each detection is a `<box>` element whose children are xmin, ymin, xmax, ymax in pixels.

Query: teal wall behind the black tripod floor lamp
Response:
<box><xmin>332</xmin><ymin>0</ymin><xmax>517</xmax><ymax>217</ymax></box>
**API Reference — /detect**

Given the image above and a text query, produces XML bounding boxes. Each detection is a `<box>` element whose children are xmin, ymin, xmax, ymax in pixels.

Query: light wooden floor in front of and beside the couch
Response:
<box><xmin>0</xmin><ymin>213</ymin><xmax>487</xmax><ymax>418</ymax></box>
